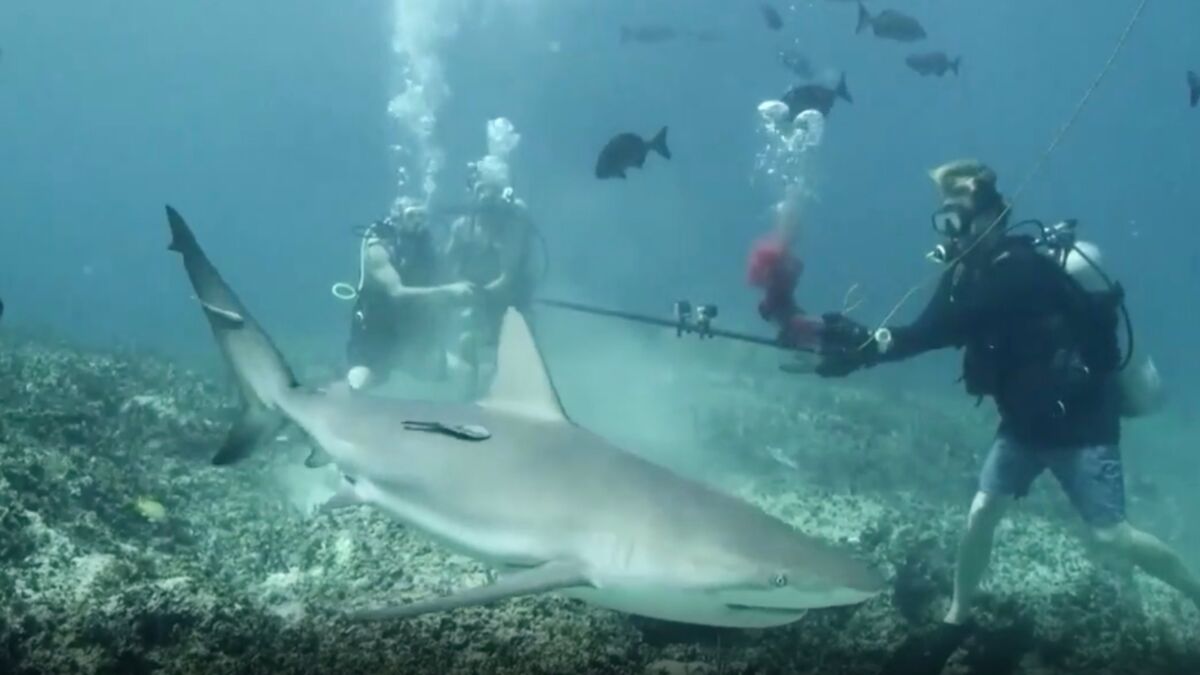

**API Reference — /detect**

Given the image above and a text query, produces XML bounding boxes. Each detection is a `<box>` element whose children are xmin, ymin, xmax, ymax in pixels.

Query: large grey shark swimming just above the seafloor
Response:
<box><xmin>167</xmin><ymin>205</ymin><xmax>884</xmax><ymax>628</ymax></box>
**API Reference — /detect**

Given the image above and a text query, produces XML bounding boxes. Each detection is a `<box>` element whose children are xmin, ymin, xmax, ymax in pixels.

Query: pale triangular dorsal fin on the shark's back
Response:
<box><xmin>480</xmin><ymin>307</ymin><xmax>568</xmax><ymax>422</ymax></box>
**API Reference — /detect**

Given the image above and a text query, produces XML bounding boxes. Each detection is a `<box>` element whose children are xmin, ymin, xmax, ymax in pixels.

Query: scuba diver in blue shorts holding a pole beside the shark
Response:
<box><xmin>816</xmin><ymin>160</ymin><xmax>1200</xmax><ymax>673</ymax></box>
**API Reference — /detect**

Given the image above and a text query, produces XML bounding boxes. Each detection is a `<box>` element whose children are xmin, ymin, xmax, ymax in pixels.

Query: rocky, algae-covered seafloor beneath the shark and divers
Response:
<box><xmin>0</xmin><ymin>340</ymin><xmax>1200</xmax><ymax>675</ymax></box>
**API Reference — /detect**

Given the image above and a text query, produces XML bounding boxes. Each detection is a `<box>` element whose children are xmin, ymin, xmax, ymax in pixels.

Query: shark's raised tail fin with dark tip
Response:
<box><xmin>167</xmin><ymin>205</ymin><xmax>296</xmax><ymax>465</ymax></box>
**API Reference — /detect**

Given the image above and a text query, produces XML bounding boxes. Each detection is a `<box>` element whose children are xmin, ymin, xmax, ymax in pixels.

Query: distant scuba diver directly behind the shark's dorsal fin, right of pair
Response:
<box><xmin>445</xmin><ymin>174</ymin><xmax>536</xmax><ymax>392</ymax></box>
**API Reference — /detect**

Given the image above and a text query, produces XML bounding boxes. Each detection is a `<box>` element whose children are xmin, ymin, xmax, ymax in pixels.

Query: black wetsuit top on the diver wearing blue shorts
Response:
<box><xmin>871</xmin><ymin>237</ymin><xmax>1121</xmax><ymax>446</ymax></box>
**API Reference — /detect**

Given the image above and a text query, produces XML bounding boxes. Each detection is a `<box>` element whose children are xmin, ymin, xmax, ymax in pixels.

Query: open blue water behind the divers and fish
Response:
<box><xmin>0</xmin><ymin>0</ymin><xmax>1200</xmax><ymax>475</ymax></box>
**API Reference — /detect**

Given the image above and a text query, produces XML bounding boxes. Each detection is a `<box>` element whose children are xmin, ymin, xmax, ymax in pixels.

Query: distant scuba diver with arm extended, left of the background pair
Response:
<box><xmin>334</xmin><ymin>203</ymin><xmax>478</xmax><ymax>390</ymax></box>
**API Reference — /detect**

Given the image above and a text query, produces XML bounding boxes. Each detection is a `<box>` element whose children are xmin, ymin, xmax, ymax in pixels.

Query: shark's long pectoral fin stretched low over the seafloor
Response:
<box><xmin>349</xmin><ymin>562</ymin><xmax>592</xmax><ymax>621</ymax></box>
